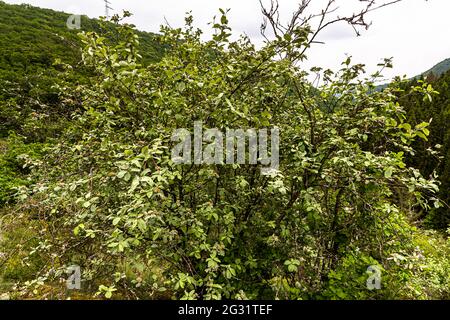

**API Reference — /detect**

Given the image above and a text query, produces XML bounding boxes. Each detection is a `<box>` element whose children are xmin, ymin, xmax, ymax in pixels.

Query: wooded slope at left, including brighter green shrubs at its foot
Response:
<box><xmin>0</xmin><ymin>1</ymin><xmax>163</xmax><ymax>205</ymax></box>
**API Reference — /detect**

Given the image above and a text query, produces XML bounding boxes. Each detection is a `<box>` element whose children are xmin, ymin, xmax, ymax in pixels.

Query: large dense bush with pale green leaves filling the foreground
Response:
<box><xmin>0</xmin><ymin>1</ymin><xmax>450</xmax><ymax>299</ymax></box>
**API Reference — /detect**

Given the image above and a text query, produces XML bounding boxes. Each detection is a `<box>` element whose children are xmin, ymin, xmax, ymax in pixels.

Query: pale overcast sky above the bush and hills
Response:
<box><xmin>5</xmin><ymin>0</ymin><xmax>450</xmax><ymax>82</ymax></box>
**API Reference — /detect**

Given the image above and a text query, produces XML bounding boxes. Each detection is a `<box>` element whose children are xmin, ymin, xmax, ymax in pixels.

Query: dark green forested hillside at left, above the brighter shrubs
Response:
<box><xmin>0</xmin><ymin>1</ymin><xmax>162</xmax><ymax>137</ymax></box>
